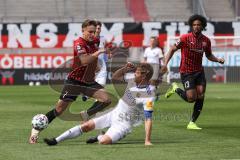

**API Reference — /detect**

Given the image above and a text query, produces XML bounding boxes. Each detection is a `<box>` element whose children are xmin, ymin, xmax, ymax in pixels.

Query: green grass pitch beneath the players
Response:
<box><xmin>0</xmin><ymin>84</ymin><xmax>240</xmax><ymax>160</ymax></box>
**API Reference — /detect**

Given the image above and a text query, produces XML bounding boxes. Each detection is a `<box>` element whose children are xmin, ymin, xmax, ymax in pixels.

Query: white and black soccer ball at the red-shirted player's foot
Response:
<box><xmin>32</xmin><ymin>114</ymin><xmax>48</xmax><ymax>130</ymax></box>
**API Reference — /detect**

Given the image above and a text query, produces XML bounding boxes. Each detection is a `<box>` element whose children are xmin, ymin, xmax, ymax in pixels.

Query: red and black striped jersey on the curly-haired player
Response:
<box><xmin>175</xmin><ymin>32</ymin><xmax>212</xmax><ymax>73</ymax></box>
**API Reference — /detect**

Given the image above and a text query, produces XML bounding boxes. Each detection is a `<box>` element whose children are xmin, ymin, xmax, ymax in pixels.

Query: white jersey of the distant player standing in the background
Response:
<box><xmin>143</xmin><ymin>47</ymin><xmax>164</xmax><ymax>64</ymax></box>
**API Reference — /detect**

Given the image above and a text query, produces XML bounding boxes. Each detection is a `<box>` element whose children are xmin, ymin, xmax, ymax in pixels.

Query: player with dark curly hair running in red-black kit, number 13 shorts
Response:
<box><xmin>164</xmin><ymin>15</ymin><xmax>224</xmax><ymax>129</ymax></box>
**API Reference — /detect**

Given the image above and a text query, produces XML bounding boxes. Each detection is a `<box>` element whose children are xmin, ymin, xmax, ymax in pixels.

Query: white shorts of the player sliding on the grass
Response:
<box><xmin>93</xmin><ymin>111</ymin><xmax>131</xmax><ymax>143</ymax></box>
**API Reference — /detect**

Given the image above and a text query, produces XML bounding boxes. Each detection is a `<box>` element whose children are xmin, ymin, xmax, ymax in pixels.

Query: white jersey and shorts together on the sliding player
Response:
<box><xmin>93</xmin><ymin>75</ymin><xmax>155</xmax><ymax>143</ymax></box>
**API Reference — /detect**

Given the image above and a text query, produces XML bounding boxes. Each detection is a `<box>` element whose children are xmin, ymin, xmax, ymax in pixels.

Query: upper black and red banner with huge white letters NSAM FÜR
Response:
<box><xmin>0</xmin><ymin>22</ymin><xmax>240</xmax><ymax>49</ymax></box>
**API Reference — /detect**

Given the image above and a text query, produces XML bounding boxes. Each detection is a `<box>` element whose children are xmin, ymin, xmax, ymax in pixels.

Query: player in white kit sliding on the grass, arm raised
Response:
<box><xmin>44</xmin><ymin>63</ymin><xmax>155</xmax><ymax>145</ymax></box>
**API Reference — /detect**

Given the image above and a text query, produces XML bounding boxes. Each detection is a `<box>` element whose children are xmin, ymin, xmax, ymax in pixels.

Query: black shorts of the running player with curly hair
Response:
<box><xmin>181</xmin><ymin>71</ymin><xmax>206</xmax><ymax>90</ymax></box>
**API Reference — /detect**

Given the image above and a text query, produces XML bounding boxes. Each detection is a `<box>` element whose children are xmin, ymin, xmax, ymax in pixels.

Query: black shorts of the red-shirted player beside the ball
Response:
<box><xmin>60</xmin><ymin>79</ymin><xmax>103</xmax><ymax>101</ymax></box>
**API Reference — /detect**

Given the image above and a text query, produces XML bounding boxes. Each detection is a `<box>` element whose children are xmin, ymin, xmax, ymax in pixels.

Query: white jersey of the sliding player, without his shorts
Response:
<box><xmin>112</xmin><ymin>79</ymin><xmax>155</xmax><ymax>126</ymax></box>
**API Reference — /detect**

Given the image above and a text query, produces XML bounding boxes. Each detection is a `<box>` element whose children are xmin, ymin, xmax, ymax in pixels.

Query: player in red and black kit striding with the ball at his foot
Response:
<box><xmin>29</xmin><ymin>20</ymin><xmax>111</xmax><ymax>144</ymax></box>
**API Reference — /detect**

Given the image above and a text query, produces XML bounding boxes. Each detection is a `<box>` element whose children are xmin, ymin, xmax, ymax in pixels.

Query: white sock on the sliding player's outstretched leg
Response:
<box><xmin>56</xmin><ymin>125</ymin><xmax>82</xmax><ymax>142</ymax></box>
